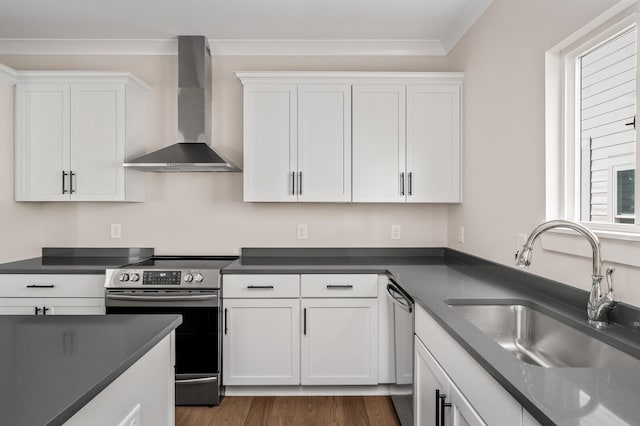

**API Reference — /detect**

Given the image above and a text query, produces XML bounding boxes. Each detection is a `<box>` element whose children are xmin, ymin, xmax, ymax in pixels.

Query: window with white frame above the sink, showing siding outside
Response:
<box><xmin>545</xmin><ymin>0</ymin><xmax>640</xmax><ymax>236</ymax></box>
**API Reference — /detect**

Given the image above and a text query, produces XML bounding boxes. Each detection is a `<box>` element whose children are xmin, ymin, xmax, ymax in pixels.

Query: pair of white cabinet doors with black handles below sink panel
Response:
<box><xmin>415</xmin><ymin>337</ymin><xmax>486</xmax><ymax>426</ymax></box>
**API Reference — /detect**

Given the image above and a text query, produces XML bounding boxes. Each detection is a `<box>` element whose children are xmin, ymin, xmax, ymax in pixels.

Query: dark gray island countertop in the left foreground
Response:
<box><xmin>0</xmin><ymin>315</ymin><xmax>182</xmax><ymax>426</ymax></box>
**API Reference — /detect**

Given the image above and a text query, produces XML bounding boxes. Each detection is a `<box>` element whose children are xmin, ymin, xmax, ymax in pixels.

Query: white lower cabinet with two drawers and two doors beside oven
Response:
<box><xmin>222</xmin><ymin>274</ymin><xmax>378</xmax><ymax>386</ymax></box>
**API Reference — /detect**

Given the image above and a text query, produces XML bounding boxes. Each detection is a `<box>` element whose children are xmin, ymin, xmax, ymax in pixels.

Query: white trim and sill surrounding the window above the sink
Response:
<box><xmin>542</xmin><ymin>0</ymin><xmax>640</xmax><ymax>266</ymax></box>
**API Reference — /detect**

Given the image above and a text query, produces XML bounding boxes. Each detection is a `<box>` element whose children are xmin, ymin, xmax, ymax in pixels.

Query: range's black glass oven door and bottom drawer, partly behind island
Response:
<box><xmin>106</xmin><ymin>290</ymin><xmax>222</xmax><ymax>405</ymax></box>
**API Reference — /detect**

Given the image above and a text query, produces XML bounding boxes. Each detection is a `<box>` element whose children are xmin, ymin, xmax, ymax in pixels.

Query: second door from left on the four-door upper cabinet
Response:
<box><xmin>297</xmin><ymin>84</ymin><xmax>351</xmax><ymax>202</ymax></box>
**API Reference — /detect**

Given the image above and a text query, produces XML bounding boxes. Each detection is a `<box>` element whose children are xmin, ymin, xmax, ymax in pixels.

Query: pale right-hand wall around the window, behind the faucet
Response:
<box><xmin>448</xmin><ymin>0</ymin><xmax>640</xmax><ymax>306</ymax></box>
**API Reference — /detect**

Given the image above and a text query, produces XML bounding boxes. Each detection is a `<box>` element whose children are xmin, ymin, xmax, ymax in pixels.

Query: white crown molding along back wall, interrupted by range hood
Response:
<box><xmin>0</xmin><ymin>38</ymin><xmax>447</xmax><ymax>56</ymax></box>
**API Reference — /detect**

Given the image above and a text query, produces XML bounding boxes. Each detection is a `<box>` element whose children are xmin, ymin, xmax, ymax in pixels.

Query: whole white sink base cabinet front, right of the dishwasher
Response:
<box><xmin>414</xmin><ymin>305</ymin><xmax>537</xmax><ymax>426</ymax></box>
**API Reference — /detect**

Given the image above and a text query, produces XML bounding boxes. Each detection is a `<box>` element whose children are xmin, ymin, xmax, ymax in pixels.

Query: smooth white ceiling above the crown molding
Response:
<box><xmin>0</xmin><ymin>0</ymin><xmax>492</xmax><ymax>54</ymax></box>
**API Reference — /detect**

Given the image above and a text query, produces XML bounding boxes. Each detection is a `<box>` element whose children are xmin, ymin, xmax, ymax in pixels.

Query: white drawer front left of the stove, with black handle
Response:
<box><xmin>0</xmin><ymin>274</ymin><xmax>104</xmax><ymax>298</ymax></box>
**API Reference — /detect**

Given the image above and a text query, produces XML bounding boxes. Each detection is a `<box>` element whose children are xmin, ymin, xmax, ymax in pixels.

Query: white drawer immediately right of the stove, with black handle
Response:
<box><xmin>222</xmin><ymin>275</ymin><xmax>300</xmax><ymax>298</ymax></box>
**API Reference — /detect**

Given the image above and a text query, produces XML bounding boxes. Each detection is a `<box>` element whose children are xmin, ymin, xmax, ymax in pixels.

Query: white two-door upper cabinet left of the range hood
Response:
<box><xmin>15</xmin><ymin>71</ymin><xmax>149</xmax><ymax>201</ymax></box>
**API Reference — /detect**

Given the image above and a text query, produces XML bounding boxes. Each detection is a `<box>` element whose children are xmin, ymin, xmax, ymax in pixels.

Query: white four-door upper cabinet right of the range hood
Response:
<box><xmin>236</xmin><ymin>72</ymin><xmax>463</xmax><ymax>203</ymax></box>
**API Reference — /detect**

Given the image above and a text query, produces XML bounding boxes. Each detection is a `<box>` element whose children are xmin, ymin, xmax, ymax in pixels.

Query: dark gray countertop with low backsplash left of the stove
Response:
<box><xmin>0</xmin><ymin>247</ymin><xmax>154</xmax><ymax>274</ymax></box>
